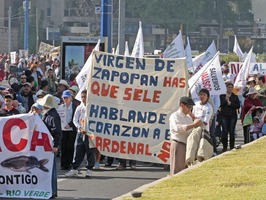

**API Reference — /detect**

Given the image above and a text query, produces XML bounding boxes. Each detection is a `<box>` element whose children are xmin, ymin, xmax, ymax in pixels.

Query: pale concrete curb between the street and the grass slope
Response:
<box><xmin>113</xmin><ymin>137</ymin><xmax>265</xmax><ymax>200</ymax></box>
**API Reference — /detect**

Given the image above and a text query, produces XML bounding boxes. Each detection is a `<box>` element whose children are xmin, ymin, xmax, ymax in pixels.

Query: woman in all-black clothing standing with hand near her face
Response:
<box><xmin>219</xmin><ymin>82</ymin><xmax>240</xmax><ymax>152</ymax></box>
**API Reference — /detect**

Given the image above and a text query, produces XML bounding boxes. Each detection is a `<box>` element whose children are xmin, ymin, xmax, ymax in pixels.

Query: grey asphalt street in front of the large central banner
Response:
<box><xmin>58</xmin><ymin>163</ymin><xmax>168</xmax><ymax>199</ymax></box>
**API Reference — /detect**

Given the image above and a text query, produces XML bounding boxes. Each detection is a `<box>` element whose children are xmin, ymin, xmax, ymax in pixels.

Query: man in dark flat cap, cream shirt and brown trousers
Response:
<box><xmin>169</xmin><ymin>97</ymin><xmax>202</xmax><ymax>176</ymax></box>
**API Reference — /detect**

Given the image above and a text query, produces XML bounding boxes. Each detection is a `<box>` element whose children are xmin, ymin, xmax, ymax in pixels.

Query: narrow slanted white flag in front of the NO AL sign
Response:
<box><xmin>234</xmin><ymin>47</ymin><xmax>253</xmax><ymax>89</ymax></box>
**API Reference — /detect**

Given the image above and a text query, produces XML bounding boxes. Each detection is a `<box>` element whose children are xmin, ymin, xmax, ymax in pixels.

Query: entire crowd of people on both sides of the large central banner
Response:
<box><xmin>0</xmin><ymin>52</ymin><xmax>266</xmax><ymax>195</ymax></box>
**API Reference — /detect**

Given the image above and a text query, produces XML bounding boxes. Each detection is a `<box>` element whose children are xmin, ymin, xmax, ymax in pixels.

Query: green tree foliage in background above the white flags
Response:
<box><xmin>126</xmin><ymin>0</ymin><xmax>253</xmax><ymax>50</ymax></box>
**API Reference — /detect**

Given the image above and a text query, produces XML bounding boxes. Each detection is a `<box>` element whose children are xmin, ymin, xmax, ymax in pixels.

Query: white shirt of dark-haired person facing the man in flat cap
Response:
<box><xmin>192</xmin><ymin>101</ymin><xmax>213</xmax><ymax>131</ymax></box>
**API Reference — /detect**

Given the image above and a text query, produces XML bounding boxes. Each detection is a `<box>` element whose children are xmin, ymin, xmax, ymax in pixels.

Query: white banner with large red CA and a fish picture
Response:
<box><xmin>0</xmin><ymin>114</ymin><xmax>54</xmax><ymax>199</ymax></box>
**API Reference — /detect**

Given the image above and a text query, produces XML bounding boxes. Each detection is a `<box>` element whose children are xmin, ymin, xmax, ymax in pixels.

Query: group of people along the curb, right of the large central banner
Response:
<box><xmin>170</xmin><ymin>64</ymin><xmax>266</xmax><ymax>175</ymax></box>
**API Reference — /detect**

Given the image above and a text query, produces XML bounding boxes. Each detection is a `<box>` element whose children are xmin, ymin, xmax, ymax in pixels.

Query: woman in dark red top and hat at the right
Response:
<box><xmin>241</xmin><ymin>88</ymin><xmax>262</xmax><ymax>144</ymax></box>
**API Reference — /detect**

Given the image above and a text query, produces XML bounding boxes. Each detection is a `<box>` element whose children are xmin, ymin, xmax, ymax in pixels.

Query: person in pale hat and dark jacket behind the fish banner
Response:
<box><xmin>37</xmin><ymin>94</ymin><xmax>62</xmax><ymax>197</ymax></box>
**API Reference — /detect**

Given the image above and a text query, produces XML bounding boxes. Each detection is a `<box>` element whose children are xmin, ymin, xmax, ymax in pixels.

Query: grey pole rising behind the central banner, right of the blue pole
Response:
<box><xmin>117</xmin><ymin>0</ymin><xmax>126</xmax><ymax>55</ymax></box>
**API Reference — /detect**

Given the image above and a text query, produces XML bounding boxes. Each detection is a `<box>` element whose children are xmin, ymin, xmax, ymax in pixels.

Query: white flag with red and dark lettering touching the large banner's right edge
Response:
<box><xmin>188</xmin><ymin>52</ymin><xmax>226</xmax><ymax>99</ymax></box>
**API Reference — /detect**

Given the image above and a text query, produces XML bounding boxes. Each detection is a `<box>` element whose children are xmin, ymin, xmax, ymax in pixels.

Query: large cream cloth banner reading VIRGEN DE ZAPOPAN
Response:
<box><xmin>87</xmin><ymin>51</ymin><xmax>188</xmax><ymax>163</ymax></box>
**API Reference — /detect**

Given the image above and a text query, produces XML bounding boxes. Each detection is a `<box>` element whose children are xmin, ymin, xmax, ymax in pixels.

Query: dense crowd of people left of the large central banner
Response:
<box><xmin>0</xmin><ymin>52</ymin><xmax>136</xmax><ymax>197</ymax></box>
